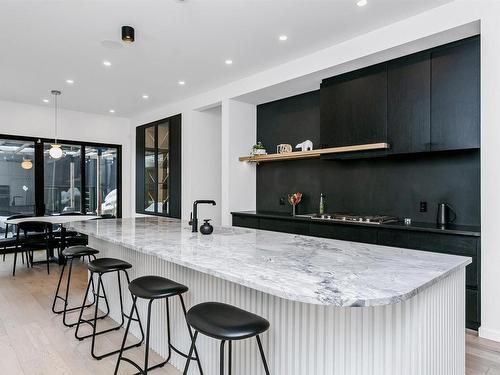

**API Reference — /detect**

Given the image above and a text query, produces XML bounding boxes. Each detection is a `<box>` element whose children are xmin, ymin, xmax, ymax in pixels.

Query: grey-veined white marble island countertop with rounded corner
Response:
<box><xmin>65</xmin><ymin>217</ymin><xmax>471</xmax><ymax>307</ymax></box>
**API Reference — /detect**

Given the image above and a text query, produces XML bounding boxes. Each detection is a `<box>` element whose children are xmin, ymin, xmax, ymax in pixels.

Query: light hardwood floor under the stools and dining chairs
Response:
<box><xmin>0</xmin><ymin>257</ymin><xmax>500</xmax><ymax>375</ymax></box>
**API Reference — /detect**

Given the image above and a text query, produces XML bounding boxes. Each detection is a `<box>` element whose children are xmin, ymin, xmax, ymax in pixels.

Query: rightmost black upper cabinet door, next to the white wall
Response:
<box><xmin>431</xmin><ymin>38</ymin><xmax>480</xmax><ymax>151</ymax></box>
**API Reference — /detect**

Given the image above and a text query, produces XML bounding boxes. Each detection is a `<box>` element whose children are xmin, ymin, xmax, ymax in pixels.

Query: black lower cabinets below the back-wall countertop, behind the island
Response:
<box><xmin>233</xmin><ymin>214</ymin><xmax>481</xmax><ymax>330</ymax></box>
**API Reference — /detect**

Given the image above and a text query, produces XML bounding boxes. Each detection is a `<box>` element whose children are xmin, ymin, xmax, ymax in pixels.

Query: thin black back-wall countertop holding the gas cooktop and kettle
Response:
<box><xmin>231</xmin><ymin>211</ymin><xmax>481</xmax><ymax>237</ymax></box>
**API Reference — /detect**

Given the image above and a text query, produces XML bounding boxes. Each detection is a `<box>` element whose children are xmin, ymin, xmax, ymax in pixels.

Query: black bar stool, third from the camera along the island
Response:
<box><xmin>75</xmin><ymin>258</ymin><xmax>144</xmax><ymax>359</ymax></box>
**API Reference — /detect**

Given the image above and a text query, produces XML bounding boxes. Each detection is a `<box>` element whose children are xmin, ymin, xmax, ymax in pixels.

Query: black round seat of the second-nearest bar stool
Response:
<box><xmin>128</xmin><ymin>276</ymin><xmax>189</xmax><ymax>299</ymax></box>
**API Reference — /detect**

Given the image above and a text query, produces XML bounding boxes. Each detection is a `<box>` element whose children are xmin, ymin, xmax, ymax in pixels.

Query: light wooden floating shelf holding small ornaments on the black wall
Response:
<box><xmin>239</xmin><ymin>143</ymin><xmax>389</xmax><ymax>163</ymax></box>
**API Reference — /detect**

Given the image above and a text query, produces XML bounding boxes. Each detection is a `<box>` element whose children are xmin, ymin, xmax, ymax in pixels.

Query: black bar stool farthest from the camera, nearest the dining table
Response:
<box><xmin>52</xmin><ymin>246</ymin><xmax>102</xmax><ymax>327</ymax></box>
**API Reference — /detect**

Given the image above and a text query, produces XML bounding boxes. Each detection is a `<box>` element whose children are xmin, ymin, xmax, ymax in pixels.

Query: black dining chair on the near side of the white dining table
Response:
<box><xmin>13</xmin><ymin>220</ymin><xmax>57</xmax><ymax>275</ymax></box>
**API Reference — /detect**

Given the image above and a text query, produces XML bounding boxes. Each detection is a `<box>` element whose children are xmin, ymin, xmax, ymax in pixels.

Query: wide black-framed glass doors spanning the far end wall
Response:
<box><xmin>0</xmin><ymin>135</ymin><xmax>121</xmax><ymax>219</ymax></box>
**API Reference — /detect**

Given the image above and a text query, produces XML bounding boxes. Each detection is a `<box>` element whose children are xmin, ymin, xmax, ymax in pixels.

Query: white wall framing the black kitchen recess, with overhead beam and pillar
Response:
<box><xmin>129</xmin><ymin>0</ymin><xmax>500</xmax><ymax>341</ymax></box>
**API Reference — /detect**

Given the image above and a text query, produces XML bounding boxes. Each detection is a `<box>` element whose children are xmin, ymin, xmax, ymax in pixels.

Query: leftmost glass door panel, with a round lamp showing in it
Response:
<box><xmin>0</xmin><ymin>139</ymin><xmax>35</xmax><ymax>237</ymax></box>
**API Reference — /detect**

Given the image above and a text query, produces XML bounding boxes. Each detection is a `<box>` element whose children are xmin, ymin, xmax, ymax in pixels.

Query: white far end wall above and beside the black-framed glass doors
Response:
<box><xmin>0</xmin><ymin>101</ymin><xmax>135</xmax><ymax>217</ymax></box>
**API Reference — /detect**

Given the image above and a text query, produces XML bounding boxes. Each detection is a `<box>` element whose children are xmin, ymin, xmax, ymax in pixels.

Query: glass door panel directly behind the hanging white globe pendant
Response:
<box><xmin>43</xmin><ymin>144</ymin><xmax>82</xmax><ymax>215</ymax></box>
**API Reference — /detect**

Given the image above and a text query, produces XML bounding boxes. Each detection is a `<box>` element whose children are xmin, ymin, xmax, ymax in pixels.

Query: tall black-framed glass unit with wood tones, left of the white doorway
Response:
<box><xmin>136</xmin><ymin>115</ymin><xmax>181</xmax><ymax>217</ymax></box>
